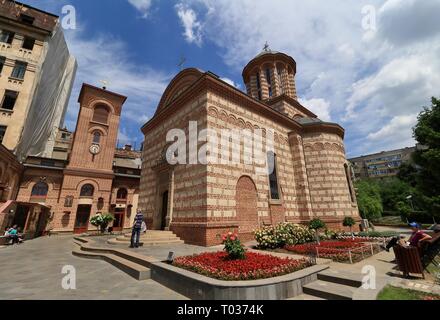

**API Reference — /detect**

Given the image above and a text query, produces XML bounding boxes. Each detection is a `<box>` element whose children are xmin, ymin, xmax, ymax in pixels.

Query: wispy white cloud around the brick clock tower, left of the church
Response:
<box><xmin>65</xmin><ymin>26</ymin><xmax>171</xmax><ymax>143</ymax></box>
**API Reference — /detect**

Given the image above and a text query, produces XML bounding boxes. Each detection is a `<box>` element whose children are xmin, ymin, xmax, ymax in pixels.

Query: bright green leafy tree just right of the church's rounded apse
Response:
<box><xmin>356</xmin><ymin>180</ymin><xmax>383</xmax><ymax>220</ymax></box>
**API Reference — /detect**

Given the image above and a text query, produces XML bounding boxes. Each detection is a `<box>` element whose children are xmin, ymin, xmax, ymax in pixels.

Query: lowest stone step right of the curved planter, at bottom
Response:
<box><xmin>303</xmin><ymin>280</ymin><xmax>355</xmax><ymax>300</ymax></box>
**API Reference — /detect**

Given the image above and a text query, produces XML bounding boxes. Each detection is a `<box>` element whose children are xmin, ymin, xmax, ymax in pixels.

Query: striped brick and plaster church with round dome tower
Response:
<box><xmin>139</xmin><ymin>48</ymin><xmax>359</xmax><ymax>245</ymax></box>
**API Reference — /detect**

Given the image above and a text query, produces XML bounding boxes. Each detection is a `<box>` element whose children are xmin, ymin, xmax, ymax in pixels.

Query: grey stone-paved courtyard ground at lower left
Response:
<box><xmin>0</xmin><ymin>236</ymin><xmax>186</xmax><ymax>300</ymax></box>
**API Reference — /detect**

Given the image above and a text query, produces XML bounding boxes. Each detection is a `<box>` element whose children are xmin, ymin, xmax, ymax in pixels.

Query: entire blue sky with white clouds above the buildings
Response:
<box><xmin>22</xmin><ymin>0</ymin><xmax>440</xmax><ymax>157</ymax></box>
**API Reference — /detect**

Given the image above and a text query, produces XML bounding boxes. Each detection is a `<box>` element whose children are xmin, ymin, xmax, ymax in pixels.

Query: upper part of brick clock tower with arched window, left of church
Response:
<box><xmin>67</xmin><ymin>84</ymin><xmax>127</xmax><ymax>173</ymax></box>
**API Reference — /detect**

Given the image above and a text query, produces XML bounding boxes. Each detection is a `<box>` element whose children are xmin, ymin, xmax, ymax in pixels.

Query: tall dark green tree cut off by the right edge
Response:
<box><xmin>413</xmin><ymin>97</ymin><xmax>440</xmax><ymax>214</ymax></box>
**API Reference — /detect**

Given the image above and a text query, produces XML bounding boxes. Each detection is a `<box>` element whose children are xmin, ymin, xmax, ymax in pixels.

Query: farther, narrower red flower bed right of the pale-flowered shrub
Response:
<box><xmin>284</xmin><ymin>238</ymin><xmax>380</xmax><ymax>263</ymax></box>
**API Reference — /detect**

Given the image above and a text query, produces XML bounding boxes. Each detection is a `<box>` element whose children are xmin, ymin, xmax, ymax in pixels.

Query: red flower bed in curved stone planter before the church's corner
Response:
<box><xmin>173</xmin><ymin>252</ymin><xmax>312</xmax><ymax>281</ymax></box>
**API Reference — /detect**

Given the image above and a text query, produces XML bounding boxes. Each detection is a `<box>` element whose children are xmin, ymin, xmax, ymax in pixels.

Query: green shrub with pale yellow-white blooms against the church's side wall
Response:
<box><xmin>255</xmin><ymin>223</ymin><xmax>314</xmax><ymax>249</ymax></box>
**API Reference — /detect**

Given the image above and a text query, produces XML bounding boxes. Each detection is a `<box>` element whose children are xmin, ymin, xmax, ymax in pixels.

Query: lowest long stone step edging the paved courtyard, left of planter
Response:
<box><xmin>72</xmin><ymin>244</ymin><xmax>151</xmax><ymax>280</ymax></box>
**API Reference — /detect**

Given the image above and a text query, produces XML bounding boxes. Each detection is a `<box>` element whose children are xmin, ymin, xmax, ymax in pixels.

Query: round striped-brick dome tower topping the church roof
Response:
<box><xmin>243</xmin><ymin>44</ymin><xmax>297</xmax><ymax>101</ymax></box>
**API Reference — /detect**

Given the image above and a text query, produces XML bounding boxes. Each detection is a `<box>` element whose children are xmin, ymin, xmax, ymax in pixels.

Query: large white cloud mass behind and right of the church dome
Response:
<box><xmin>175</xmin><ymin>0</ymin><xmax>440</xmax><ymax>154</ymax></box>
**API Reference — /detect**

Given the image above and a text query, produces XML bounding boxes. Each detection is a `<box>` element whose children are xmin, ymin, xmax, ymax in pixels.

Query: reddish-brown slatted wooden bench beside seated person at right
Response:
<box><xmin>393</xmin><ymin>245</ymin><xmax>425</xmax><ymax>279</ymax></box>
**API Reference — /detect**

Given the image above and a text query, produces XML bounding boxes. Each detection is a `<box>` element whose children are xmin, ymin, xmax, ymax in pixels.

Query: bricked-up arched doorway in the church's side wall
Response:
<box><xmin>235</xmin><ymin>176</ymin><xmax>258</xmax><ymax>241</ymax></box>
